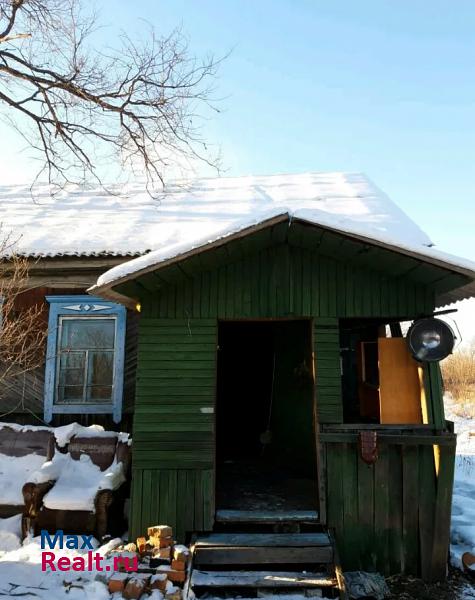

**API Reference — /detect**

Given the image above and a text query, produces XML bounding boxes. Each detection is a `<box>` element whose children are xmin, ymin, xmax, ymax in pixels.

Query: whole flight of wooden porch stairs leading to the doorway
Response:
<box><xmin>189</xmin><ymin>530</ymin><xmax>345</xmax><ymax>598</ymax></box>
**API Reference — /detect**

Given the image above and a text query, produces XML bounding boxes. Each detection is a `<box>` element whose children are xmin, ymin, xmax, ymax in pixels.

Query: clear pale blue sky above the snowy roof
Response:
<box><xmin>0</xmin><ymin>0</ymin><xmax>475</xmax><ymax>342</ymax></box>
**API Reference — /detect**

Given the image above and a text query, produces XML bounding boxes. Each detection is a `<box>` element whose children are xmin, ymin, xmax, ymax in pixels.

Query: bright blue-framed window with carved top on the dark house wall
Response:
<box><xmin>44</xmin><ymin>296</ymin><xmax>126</xmax><ymax>423</ymax></box>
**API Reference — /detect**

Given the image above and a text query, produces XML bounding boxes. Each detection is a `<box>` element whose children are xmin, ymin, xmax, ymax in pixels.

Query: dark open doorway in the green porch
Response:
<box><xmin>216</xmin><ymin>320</ymin><xmax>318</xmax><ymax>512</ymax></box>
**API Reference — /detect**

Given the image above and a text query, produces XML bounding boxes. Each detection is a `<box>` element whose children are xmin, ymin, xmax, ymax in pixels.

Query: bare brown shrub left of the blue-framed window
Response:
<box><xmin>0</xmin><ymin>236</ymin><xmax>47</xmax><ymax>386</ymax></box>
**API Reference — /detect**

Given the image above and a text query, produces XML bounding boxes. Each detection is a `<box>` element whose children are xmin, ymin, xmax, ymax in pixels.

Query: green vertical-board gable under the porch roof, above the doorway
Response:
<box><xmin>142</xmin><ymin>245</ymin><xmax>434</xmax><ymax>319</ymax></box>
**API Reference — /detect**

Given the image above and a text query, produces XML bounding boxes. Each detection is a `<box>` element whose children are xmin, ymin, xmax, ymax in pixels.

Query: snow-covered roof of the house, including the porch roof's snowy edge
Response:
<box><xmin>0</xmin><ymin>173</ymin><xmax>475</xmax><ymax>296</ymax></box>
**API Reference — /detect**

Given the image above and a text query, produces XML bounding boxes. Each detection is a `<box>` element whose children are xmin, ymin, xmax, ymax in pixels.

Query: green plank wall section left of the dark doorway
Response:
<box><xmin>130</xmin><ymin>317</ymin><xmax>217</xmax><ymax>540</ymax></box>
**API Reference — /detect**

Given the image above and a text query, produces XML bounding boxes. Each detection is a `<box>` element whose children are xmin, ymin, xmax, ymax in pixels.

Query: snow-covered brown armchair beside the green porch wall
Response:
<box><xmin>23</xmin><ymin>432</ymin><xmax>130</xmax><ymax>538</ymax></box>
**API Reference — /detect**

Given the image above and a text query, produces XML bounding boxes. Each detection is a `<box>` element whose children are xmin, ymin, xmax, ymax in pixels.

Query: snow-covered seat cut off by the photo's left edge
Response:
<box><xmin>0</xmin><ymin>424</ymin><xmax>55</xmax><ymax>518</ymax></box>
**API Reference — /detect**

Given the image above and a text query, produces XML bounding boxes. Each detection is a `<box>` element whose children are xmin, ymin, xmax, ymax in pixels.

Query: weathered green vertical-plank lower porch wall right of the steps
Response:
<box><xmin>322</xmin><ymin>434</ymin><xmax>455</xmax><ymax>581</ymax></box>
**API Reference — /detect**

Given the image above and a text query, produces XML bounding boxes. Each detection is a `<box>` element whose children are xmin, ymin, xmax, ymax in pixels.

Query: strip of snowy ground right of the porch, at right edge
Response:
<box><xmin>446</xmin><ymin>397</ymin><xmax>475</xmax><ymax>568</ymax></box>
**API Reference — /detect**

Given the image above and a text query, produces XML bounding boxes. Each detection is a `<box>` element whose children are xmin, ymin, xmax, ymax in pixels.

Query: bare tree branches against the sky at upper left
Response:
<box><xmin>0</xmin><ymin>0</ymin><xmax>218</xmax><ymax>189</ymax></box>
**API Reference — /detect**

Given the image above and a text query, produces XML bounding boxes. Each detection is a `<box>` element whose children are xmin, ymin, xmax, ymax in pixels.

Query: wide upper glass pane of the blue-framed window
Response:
<box><xmin>61</xmin><ymin>318</ymin><xmax>115</xmax><ymax>350</ymax></box>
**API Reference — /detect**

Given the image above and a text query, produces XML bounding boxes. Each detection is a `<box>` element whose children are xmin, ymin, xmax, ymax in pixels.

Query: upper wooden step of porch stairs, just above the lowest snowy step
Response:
<box><xmin>194</xmin><ymin>533</ymin><xmax>333</xmax><ymax>567</ymax></box>
